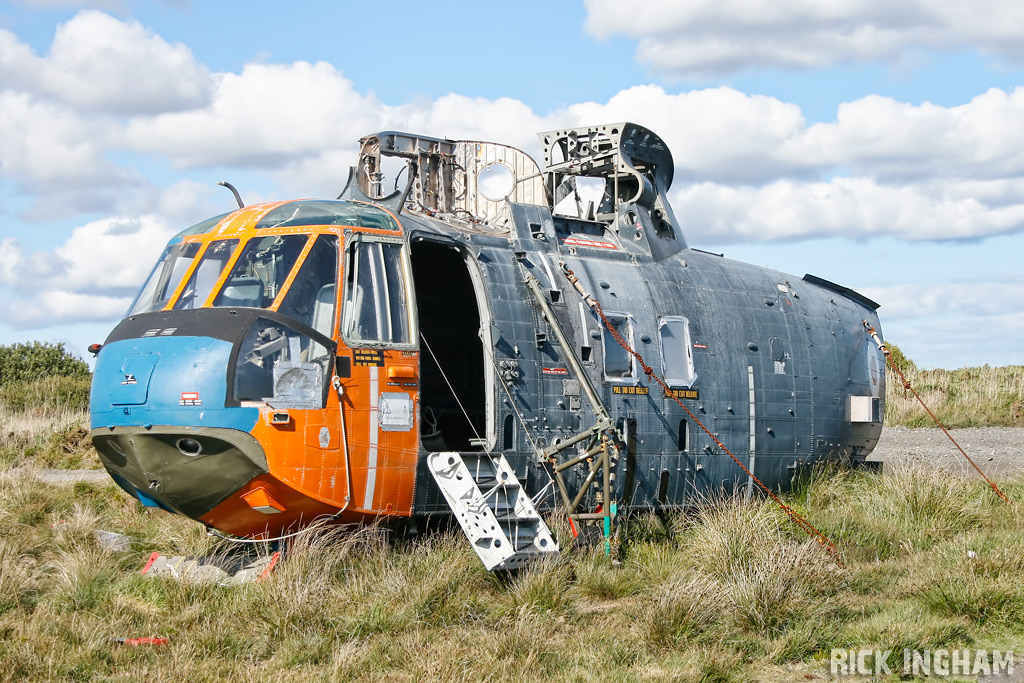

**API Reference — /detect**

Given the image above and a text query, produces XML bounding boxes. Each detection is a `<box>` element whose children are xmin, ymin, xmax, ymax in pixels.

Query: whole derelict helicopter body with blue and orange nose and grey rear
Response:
<box><xmin>91</xmin><ymin>124</ymin><xmax>885</xmax><ymax>538</ymax></box>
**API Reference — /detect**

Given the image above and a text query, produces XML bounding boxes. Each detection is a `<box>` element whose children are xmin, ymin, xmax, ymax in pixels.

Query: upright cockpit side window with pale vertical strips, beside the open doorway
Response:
<box><xmin>342</xmin><ymin>236</ymin><xmax>413</xmax><ymax>344</ymax></box>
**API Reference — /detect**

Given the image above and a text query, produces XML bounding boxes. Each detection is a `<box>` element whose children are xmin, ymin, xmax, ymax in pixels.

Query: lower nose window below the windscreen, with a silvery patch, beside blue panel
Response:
<box><xmin>231</xmin><ymin>317</ymin><xmax>334</xmax><ymax>410</ymax></box>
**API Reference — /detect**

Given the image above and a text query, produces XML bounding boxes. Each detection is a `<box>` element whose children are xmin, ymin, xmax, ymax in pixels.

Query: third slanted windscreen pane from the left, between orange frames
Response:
<box><xmin>207</xmin><ymin>234</ymin><xmax>308</xmax><ymax>308</ymax></box>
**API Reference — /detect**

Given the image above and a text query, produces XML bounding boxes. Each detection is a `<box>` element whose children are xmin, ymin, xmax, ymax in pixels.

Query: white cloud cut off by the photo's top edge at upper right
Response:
<box><xmin>585</xmin><ymin>0</ymin><xmax>1024</xmax><ymax>77</ymax></box>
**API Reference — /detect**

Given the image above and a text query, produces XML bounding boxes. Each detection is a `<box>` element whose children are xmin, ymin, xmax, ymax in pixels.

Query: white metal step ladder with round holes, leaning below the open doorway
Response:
<box><xmin>427</xmin><ymin>453</ymin><xmax>558</xmax><ymax>570</ymax></box>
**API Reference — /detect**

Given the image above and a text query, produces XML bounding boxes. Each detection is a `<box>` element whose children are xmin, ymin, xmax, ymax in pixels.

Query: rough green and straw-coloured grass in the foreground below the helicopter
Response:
<box><xmin>0</xmin><ymin>462</ymin><xmax>1024</xmax><ymax>681</ymax></box>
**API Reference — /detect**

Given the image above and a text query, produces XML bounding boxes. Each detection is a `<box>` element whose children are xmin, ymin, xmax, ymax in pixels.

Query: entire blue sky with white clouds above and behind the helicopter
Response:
<box><xmin>0</xmin><ymin>0</ymin><xmax>1024</xmax><ymax>368</ymax></box>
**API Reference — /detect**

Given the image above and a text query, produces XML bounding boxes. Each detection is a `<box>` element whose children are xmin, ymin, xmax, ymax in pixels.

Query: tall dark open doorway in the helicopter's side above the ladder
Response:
<box><xmin>411</xmin><ymin>240</ymin><xmax>489</xmax><ymax>452</ymax></box>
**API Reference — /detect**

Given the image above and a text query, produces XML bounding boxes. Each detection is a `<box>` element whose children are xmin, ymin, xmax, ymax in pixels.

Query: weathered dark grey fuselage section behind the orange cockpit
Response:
<box><xmin>349</xmin><ymin>124</ymin><xmax>885</xmax><ymax>514</ymax></box>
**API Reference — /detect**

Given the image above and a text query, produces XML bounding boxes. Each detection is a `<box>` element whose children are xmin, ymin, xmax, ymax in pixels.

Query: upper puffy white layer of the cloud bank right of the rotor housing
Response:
<box><xmin>567</xmin><ymin>85</ymin><xmax>1024</xmax><ymax>184</ymax></box>
